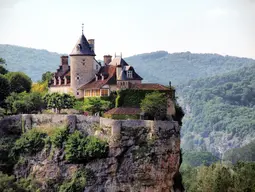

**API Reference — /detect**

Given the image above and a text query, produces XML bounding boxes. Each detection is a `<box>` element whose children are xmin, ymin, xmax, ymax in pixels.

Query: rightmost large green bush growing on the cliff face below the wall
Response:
<box><xmin>65</xmin><ymin>131</ymin><xmax>108</xmax><ymax>163</ymax></box>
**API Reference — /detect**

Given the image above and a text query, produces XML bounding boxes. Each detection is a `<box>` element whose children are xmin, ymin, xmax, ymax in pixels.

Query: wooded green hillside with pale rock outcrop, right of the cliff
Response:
<box><xmin>179</xmin><ymin>65</ymin><xmax>255</xmax><ymax>156</ymax></box>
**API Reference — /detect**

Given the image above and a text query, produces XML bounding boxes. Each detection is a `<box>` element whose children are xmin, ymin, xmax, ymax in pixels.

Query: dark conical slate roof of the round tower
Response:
<box><xmin>70</xmin><ymin>34</ymin><xmax>96</xmax><ymax>56</ymax></box>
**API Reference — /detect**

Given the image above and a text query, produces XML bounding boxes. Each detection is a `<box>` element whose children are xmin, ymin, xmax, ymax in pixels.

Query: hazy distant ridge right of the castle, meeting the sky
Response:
<box><xmin>126</xmin><ymin>51</ymin><xmax>255</xmax><ymax>85</ymax></box>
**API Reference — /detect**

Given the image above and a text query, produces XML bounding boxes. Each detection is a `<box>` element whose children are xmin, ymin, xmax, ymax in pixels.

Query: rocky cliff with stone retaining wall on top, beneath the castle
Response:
<box><xmin>0</xmin><ymin>115</ymin><xmax>183</xmax><ymax>192</ymax></box>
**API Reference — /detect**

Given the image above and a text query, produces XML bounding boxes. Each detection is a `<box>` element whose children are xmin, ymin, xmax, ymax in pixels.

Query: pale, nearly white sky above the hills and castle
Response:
<box><xmin>0</xmin><ymin>0</ymin><xmax>255</xmax><ymax>59</ymax></box>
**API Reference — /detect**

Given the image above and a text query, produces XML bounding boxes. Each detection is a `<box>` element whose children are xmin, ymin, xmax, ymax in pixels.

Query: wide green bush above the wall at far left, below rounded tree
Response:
<box><xmin>5</xmin><ymin>92</ymin><xmax>44</xmax><ymax>113</ymax></box>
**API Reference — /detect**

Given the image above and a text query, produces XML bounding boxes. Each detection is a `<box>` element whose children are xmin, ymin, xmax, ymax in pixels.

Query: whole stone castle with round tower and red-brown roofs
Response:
<box><xmin>49</xmin><ymin>26</ymin><xmax>170</xmax><ymax>98</ymax></box>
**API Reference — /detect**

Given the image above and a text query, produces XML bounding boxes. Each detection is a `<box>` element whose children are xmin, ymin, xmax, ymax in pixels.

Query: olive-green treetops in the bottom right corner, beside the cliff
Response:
<box><xmin>181</xmin><ymin>162</ymin><xmax>255</xmax><ymax>192</ymax></box>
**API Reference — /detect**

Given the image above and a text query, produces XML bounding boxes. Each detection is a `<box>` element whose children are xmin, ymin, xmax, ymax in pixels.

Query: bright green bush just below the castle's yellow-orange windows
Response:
<box><xmin>84</xmin><ymin>97</ymin><xmax>111</xmax><ymax>114</ymax></box>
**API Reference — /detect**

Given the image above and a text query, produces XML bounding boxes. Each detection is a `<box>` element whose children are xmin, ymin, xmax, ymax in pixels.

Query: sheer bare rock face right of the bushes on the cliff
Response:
<box><xmin>85</xmin><ymin>121</ymin><xmax>180</xmax><ymax>192</ymax></box>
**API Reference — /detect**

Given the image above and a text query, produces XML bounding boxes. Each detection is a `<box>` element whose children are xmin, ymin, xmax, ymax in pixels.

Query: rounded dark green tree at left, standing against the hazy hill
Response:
<box><xmin>5</xmin><ymin>72</ymin><xmax>32</xmax><ymax>93</ymax></box>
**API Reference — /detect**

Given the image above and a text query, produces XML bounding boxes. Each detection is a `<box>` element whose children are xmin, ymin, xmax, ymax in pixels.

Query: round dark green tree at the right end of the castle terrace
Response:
<box><xmin>141</xmin><ymin>92</ymin><xmax>167</xmax><ymax>119</ymax></box>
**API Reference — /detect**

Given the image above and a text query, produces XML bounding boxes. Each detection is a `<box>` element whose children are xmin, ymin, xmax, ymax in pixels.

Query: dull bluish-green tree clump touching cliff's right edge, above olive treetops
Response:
<box><xmin>183</xmin><ymin>151</ymin><xmax>219</xmax><ymax>167</ymax></box>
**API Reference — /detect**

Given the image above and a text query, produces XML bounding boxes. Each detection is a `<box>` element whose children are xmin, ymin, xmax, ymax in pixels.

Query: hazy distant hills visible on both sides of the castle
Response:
<box><xmin>0</xmin><ymin>44</ymin><xmax>255</xmax><ymax>85</ymax></box>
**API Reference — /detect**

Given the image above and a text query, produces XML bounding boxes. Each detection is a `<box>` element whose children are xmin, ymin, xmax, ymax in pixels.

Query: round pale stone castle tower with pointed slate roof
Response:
<box><xmin>70</xmin><ymin>27</ymin><xmax>96</xmax><ymax>98</ymax></box>
